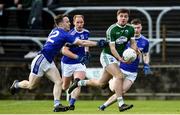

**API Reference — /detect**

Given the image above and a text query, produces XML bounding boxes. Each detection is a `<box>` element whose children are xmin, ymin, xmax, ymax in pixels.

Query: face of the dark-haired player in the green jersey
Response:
<box><xmin>117</xmin><ymin>13</ymin><xmax>129</xmax><ymax>26</ymax></box>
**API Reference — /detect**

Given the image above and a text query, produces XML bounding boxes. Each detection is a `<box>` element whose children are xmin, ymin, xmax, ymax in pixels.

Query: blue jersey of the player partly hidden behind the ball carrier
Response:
<box><xmin>120</xmin><ymin>35</ymin><xmax>149</xmax><ymax>72</ymax></box>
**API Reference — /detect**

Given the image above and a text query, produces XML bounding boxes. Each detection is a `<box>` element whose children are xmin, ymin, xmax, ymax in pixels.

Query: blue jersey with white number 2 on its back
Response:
<box><xmin>41</xmin><ymin>28</ymin><xmax>76</xmax><ymax>63</ymax></box>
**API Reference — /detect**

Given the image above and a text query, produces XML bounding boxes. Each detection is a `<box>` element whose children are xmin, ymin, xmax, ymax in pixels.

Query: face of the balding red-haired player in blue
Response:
<box><xmin>74</xmin><ymin>17</ymin><xmax>84</xmax><ymax>31</ymax></box>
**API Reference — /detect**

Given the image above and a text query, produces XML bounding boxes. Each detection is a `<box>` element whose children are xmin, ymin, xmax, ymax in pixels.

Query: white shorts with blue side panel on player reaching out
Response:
<box><xmin>31</xmin><ymin>54</ymin><xmax>55</xmax><ymax>77</ymax></box>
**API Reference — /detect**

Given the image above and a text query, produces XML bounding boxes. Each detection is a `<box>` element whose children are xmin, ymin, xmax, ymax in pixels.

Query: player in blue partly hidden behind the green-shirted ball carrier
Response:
<box><xmin>99</xmin><ymin>19</ymin><xmax>151</xmax><ymax>111</ymax></box>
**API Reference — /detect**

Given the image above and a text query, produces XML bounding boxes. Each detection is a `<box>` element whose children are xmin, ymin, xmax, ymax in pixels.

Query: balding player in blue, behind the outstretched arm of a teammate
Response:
<box><xmin>61</xmin><ymin>15</ymin><xmax>89</xmax><ymax>110</ymax></box>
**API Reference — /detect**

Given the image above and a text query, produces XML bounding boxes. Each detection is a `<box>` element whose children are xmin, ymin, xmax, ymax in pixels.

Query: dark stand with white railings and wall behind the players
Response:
<box><xmin>0</xmin><ymin>0</ymin><xmax>180</xmax><ymax>99</ymax></box>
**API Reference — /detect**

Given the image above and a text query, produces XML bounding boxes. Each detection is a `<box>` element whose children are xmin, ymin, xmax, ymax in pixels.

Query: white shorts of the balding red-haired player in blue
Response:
<box><xmin>61</xmin><ymin>62</ymin><xmax>86</xmax><ymax>77</ymax></box>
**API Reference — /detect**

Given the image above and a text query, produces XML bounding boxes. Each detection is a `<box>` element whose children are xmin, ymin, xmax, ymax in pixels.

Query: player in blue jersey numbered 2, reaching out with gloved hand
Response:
<box><xmin>10</xmin><ymin>15</ymin><xmax>106</xmax><ymax>112</ymax></box>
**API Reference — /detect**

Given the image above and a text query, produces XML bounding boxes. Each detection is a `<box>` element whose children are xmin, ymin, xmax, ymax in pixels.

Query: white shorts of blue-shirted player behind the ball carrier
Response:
<box><xmin>121</xmin><ymin>69</ymin><xmax>137</xmax><ymax>83</ymax></box>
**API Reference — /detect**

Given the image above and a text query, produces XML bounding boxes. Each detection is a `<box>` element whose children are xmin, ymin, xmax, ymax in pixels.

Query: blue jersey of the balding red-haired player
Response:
<box><xmin>61</xmin><ymin>28</ymin><xmax>89</xmax><ymax>64</ymax></box>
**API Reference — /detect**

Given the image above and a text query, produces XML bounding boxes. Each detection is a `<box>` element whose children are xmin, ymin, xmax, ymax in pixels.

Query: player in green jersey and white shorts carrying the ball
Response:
<box><xmin>69</xmin><ymin>9</ymin><xmax>137</xmax><ymax>112</ymax></box>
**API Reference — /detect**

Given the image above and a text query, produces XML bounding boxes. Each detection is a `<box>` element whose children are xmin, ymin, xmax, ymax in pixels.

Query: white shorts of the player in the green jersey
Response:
<box><xmin>100</xmin><ymin>52</ymin><xmax>119</xmax><ymax>68</ymax></box>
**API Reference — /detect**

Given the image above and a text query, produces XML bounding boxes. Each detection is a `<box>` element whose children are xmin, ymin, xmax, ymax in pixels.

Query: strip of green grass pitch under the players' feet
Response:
<box><xmin>0</xmin><ymin>100</ymin><xmax>180</xmax><ymax>114</ymax></box>
